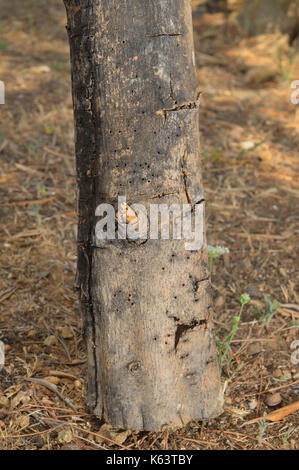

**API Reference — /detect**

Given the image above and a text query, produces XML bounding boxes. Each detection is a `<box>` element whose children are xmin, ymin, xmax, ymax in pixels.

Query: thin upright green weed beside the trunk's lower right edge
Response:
<box><xmin>216</xmin><ymin>294</ymin><xmax>251</xmax><ymax>374</ymax></box>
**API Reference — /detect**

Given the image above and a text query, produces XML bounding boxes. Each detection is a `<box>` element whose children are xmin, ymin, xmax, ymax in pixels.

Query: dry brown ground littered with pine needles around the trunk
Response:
<box><xmin>0</xmin><ymin>0</ymin><xmax>299</xmax><ymax>450</ymax></box>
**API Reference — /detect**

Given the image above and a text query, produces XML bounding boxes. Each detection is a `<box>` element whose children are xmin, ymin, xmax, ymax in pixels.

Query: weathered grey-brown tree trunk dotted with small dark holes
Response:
<box><xmin>64</xmin><ymin>0</ymin><xmax>222</xmax><ymax>431</ymax></box>
